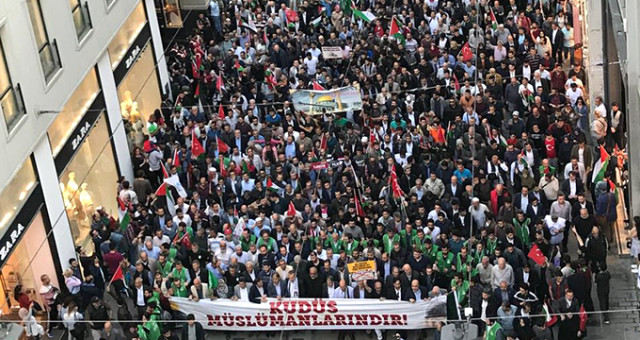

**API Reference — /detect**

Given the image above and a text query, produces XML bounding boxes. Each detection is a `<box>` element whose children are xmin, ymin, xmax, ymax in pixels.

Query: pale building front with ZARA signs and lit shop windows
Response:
<box><xmin>0</xmin><ymin>0</ymin><xmax>170</xmax><ymax>313</ymax></box>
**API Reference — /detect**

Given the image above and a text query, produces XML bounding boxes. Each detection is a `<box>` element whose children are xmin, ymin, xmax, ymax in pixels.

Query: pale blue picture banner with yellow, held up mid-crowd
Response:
<box><xmin>291</xmin><ymin>86</ymin><xmax>362</xmax><ymax>115</ymax></box>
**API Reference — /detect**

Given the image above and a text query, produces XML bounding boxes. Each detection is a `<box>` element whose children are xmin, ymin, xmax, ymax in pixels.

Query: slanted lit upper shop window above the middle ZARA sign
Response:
<box><xmin>48</xmin><ymin>68</ymin><xmax>100</xmax><ymax>157</ymax></box>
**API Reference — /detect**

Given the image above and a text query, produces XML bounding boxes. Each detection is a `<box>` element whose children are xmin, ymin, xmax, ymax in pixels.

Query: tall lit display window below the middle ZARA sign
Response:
<box><xmin>60</xmin><ymin>114</ymin><xmax>118</xmax><ymax>253</ymax></box>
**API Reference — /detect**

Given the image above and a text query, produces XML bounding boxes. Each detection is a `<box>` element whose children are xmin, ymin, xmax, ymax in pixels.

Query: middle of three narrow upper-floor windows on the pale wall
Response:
<box><xmin>27</xmin><ymin>0</ymin><xmax>62</xmax><ymax>82</ymax></box>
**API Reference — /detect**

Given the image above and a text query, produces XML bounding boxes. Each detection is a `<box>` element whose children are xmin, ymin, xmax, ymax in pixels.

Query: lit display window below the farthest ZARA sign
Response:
<box><xmin>118</xmin><ymin>42</ymin><xmax>162</xmax><ymax>150</ymax></box>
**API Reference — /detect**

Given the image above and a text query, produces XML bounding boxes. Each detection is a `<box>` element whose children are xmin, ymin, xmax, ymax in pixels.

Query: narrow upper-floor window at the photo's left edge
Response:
<box><xmin>0</xmin><ymin>39</ymin><xmax>26</xmax><ymax>131</ymax></box>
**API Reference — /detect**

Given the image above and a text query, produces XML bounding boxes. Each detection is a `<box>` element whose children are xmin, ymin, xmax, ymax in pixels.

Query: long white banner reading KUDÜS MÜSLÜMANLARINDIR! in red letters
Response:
<box><xmin>171</xmin><ymin>296</ymin><xmax>446</xmax><ymax>332</ymax></box>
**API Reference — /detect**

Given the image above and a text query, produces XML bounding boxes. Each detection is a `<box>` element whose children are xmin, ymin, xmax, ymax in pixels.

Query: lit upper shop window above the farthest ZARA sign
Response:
<box><xmin>107</xmin><ymin>2</ymin><xmax>147</xmax><ymax>70</ymax></box>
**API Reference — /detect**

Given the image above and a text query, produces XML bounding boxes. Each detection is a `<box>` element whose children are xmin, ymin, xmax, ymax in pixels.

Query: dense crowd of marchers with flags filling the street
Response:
<box><xmin>13</xmin><ymin>0</ymin><xmax>625</xmax><ymax>340</ymax></box>
